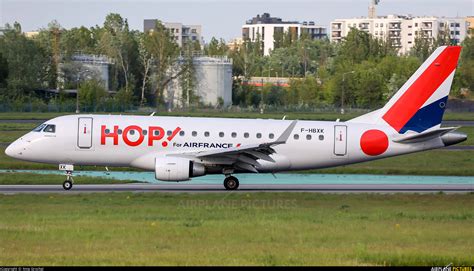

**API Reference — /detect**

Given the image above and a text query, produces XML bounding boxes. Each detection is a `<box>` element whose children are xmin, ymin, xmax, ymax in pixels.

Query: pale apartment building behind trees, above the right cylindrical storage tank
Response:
<box><xmin>143</xmin><ymin>19</ymin><xmax>204</xmax><ymax>47</ymax></box>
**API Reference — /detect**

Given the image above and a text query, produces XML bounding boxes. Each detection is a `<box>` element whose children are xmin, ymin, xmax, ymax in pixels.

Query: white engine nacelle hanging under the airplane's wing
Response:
<box><xmin>155</xmin><ymin>157</ymin><xmax>206</xmax><ymax>182</ymax></box>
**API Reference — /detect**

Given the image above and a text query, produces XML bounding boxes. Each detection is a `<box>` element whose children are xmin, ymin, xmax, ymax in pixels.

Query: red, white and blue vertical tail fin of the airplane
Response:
<box><xmin>350</xmin><ymin>46</ymin><xmax>461</xmax><ymax>134</ymax></box>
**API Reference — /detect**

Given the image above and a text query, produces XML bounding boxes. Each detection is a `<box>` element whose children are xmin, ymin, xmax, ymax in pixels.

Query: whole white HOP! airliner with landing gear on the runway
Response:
<box><xmin>5</xmin><ymin>46</ymin><xmax>467</xmax><ymax>190</ymax></box>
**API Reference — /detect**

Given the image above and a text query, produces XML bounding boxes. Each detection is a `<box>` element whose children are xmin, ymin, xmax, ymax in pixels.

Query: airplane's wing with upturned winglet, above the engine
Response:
<box><xmin>168</xmin><ymin>120</ymin><xmax>297</xmax><ymax>172</ymax></box>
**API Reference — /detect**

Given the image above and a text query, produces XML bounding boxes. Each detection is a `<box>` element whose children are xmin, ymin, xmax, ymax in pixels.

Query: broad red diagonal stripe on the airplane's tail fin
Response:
<box><xmin>382</xmin><ymin>46</ymin><xmax>461</xmax><ymax>131</ymax></box>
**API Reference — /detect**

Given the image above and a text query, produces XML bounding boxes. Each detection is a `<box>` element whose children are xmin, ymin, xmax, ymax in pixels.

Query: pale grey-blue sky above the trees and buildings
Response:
<box><xmin>0</xmin><ymin>0</ymin><xmax>474</xmax><ymax>41</ymax></box>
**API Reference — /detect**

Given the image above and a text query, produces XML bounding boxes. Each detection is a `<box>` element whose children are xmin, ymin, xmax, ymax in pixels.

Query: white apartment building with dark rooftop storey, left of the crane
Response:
<box><xmin>242</xmin><ymin>13</ymin><xmax>327</xmax><ymax>55</ymax></box>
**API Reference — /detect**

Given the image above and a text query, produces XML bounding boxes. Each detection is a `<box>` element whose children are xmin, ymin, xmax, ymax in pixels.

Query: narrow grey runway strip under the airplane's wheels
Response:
<box><xmin>0</xmin><ymin>184</ymin><xmax>474</xmax><ymax>195</ymax></box>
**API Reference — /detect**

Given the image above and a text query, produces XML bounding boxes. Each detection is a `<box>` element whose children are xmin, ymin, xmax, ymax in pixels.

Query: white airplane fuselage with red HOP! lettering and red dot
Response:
<box><xmin>4</xmin><ymin>115</ymin><xmax>445</xmax><ymax>174</ymax></box>
